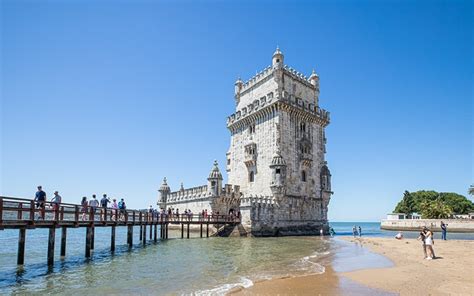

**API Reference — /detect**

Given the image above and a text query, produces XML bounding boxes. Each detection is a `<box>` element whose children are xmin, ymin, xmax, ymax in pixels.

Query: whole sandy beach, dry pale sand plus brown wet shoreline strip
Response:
<box><xmin>233</xmin><ymin>237</ymin><xmax>474</xmax><ymax>295</ymax></box>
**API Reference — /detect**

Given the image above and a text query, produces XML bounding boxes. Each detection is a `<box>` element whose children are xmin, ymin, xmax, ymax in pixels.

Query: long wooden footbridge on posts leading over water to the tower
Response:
<box><xmin>0</xmin><ymin>196</ymin><xmax>240</xmax><ymax>265</ymax></box>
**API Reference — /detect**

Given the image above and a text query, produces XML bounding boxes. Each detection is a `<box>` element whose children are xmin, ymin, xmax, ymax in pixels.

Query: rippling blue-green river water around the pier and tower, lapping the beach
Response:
<box><xmin>0</xmin><ymin>222</ymin><xmax>474</xmax><ymax>295</ymax></box>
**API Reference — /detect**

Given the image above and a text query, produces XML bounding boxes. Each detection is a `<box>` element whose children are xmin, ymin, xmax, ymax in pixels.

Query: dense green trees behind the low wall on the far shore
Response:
<box><xmin>394</xmin><ymin>191</ymin><xmax>474</xmax><ymax>219</ymax></box>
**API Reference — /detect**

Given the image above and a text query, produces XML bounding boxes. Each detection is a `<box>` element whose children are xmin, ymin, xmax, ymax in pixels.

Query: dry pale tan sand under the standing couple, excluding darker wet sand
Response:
<box><xmin>342</xmin><ymin>238</ymin><xmax>474</xmax><ymax>295</ymax></box>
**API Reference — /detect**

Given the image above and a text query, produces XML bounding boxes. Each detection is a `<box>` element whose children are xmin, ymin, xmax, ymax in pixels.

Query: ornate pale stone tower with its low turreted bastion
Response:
<box><xmin>157</xmin><ymin>48</ymin><xmax>332</xmax><ymax>236</ymax></box>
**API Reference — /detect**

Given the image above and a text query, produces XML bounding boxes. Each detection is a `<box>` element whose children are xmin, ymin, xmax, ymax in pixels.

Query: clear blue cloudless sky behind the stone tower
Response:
<box><xmin>0</xmin><ymin>0</ymin><xmax>474</xmax><ymax>221</ymax></box>
